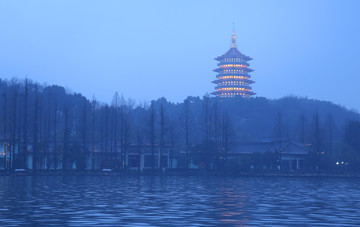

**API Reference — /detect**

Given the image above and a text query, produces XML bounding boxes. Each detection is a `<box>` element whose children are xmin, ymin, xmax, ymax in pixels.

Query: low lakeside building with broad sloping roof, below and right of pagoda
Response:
<box><xmin>190</xmin><ymin>138</ymin><xmax>309</xmax><ymax>171</ymax></box>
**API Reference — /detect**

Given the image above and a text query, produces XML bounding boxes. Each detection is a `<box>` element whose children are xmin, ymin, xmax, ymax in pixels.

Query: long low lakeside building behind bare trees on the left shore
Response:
<box><xmin>0</xmin><ymin>140</ymin><xmax>177</xmax><ymax>171</ymax></box>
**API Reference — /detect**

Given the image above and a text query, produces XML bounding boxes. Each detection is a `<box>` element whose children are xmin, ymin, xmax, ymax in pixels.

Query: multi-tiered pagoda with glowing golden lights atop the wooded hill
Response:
<box><xmin>211</xmin><ymin>26</ymin><xmax>255</xmax><ymax>97</ymax></box>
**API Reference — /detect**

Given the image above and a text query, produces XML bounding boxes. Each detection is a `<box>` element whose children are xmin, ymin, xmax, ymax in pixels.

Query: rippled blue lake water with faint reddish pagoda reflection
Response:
<box><xmin>0</xmin><ymin>176</ymin><xmax>360</xmax><ymax>226</ymax></box>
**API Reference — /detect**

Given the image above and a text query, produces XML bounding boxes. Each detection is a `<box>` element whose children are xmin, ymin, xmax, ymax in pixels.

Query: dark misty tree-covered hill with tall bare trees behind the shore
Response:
<box><xmin>0</xmin><ymin>79</ymin><xmax>360</xmax><ymax>171</ymax></box>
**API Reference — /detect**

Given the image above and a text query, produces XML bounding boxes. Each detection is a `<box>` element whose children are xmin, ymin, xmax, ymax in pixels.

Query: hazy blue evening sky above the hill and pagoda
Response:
<box><xmin>0</xmin><ymin>0</ymin><xmax>360</xmax><ymax>110</ymax></box>
